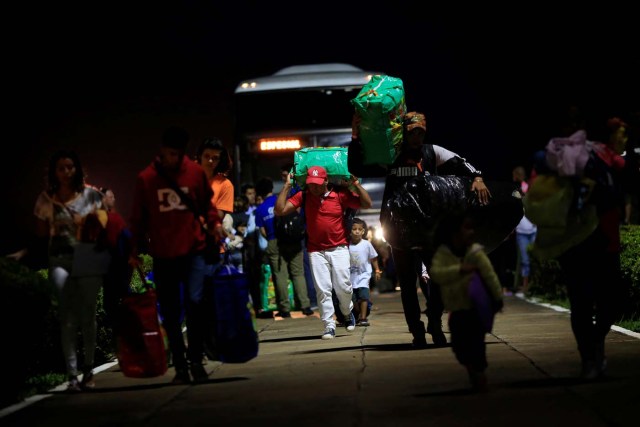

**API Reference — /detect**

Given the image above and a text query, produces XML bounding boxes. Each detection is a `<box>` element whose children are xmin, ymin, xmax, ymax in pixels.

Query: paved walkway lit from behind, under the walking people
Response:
<box><xmin>0</xmin><ymin>293</ymin><xmax>640</xmax><ymax>427</ymax></box>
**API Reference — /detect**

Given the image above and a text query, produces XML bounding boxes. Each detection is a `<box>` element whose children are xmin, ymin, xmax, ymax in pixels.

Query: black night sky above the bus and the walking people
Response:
<box><xmin>2</xmin><ymin>1</ymin><xmax>640</xmax><ymax>252</ymax></box>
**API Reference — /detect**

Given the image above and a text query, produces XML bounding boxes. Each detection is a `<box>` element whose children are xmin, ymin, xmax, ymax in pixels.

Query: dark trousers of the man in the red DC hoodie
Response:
<box><xmin>153</xmin><ymin>255</ymin><xmax>205</xmax><ymax>369</ymax></box>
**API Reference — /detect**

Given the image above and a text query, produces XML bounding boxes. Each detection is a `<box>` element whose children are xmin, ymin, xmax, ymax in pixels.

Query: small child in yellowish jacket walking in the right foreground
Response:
<box><xmin>429</xmin><ymin>213</ymin><xmax>503</xmax><ymax>391</ymax></box>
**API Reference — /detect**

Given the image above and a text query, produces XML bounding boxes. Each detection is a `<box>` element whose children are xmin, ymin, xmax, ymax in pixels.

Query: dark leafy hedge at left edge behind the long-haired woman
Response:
<box><xmin>0</xmin><ymin>255</ymin><xmax>153</xmax><ymax>407</ymax></box>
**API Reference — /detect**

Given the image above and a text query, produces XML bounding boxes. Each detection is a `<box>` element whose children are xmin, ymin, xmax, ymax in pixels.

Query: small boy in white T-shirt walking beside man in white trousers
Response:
<box><xmin>349</xmin><ymin>218</ymin><xmax>382</xmax><ymax>326</ymax></box>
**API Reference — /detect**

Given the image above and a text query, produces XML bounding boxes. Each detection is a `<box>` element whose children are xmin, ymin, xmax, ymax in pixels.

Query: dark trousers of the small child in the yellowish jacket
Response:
<box><xmin>449</xmin><ymin>310</ymin><xmax>487</xmax><ymax>372</ymax></box>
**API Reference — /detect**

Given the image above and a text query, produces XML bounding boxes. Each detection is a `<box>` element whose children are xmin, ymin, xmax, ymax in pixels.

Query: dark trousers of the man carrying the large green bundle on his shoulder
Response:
<box><xmin>391</xmin><ymin>248</ymin><xmax>444</xmax><ymax>336</ymax></box>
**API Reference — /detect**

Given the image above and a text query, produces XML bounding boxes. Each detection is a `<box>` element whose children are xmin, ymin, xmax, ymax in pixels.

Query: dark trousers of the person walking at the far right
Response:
<box><xmin>559</xmin><ymin>228</ymin><xmax>627</xmax><ymax>362</ymax></box>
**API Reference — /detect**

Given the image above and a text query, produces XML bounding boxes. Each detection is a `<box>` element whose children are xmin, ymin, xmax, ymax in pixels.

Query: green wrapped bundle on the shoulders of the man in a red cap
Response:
<box><xmin>292</xmin><ymin>147</ymin><xmax>351</xmax><ymax>188</ymax></box>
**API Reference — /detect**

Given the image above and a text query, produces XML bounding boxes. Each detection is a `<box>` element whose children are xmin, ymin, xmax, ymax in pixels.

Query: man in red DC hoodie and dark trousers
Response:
<box><xmin>130</xmin><ymin>126</ymin><xmax>222</xmax><ymax>384</ymax></box>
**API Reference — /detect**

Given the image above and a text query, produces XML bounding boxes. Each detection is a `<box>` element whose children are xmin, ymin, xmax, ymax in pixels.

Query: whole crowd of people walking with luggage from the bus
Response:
<box><xmin>7</xmin><ymin>103</ymin><xmax>640</xmax><ymax>391</ymax></box>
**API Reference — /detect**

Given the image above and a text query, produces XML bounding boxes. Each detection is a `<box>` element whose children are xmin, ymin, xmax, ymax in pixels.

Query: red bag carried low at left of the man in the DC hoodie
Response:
<box><xmin>116</xmin><ymin>268</ymin><xmax>168</xmax><ymax>378</ymax></box>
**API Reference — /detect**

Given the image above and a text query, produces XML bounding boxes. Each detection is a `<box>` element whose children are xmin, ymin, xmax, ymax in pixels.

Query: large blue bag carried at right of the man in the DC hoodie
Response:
<box><xmin>213</xmin><ymin>257</ymin><xmax>258</xmax><ymax>363</ymax></box>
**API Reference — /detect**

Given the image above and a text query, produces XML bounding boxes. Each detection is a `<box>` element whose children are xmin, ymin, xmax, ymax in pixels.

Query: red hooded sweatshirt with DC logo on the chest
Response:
<box><xmin>131</xmin><ymin>157</ymin><xmax>220</xmax><ymax>258</ymax></box>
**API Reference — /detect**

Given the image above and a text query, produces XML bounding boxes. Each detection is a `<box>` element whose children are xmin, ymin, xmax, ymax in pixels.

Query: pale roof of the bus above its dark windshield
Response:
<box><xmin>235</xmin><ymin>63</ymin><xmax>381</xmax><ymax>94</ymax></box>
